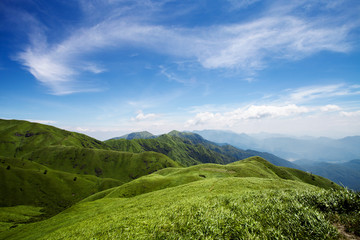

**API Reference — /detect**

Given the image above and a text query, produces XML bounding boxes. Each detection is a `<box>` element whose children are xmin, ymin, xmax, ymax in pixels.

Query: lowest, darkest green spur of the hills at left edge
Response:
<box><xmin>0</xmin><ymin>157</ymin><xmax>123</xmax><ymax>215</ymax></box>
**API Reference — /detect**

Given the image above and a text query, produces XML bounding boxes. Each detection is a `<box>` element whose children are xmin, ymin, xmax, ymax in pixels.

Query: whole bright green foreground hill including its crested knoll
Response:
<box><xmin>0</xmin><ymin>158</ymin><xmax>360</xmax><ymax>239</ymax></box>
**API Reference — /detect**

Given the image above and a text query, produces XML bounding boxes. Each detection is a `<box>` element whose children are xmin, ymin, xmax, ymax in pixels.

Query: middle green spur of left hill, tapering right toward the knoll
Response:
<box><xmin>26</xmin><ymin>146</ymin><xmax>179</xmax><ymax>182</ymax></box>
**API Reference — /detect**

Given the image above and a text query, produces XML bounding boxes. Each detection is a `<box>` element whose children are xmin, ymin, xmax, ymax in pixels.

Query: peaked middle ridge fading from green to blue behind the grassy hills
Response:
<box><xmin>105</xmin><ymin>131</ymin><xmax>299</xmax><ymax>168</ymax></box>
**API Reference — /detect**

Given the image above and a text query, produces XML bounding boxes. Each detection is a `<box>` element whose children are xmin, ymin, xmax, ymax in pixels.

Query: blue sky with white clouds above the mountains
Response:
<box><xmin>0</xmin><ymin>0</ymin><xmax>360</xmax><ymax>140</ymax></box>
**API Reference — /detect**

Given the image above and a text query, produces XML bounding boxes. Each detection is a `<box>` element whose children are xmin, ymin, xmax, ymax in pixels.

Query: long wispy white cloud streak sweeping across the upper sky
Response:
<box><xmin>16</xmin><ymin>1</ymin><xmax>357</xmax><ymax>95</ymax></box>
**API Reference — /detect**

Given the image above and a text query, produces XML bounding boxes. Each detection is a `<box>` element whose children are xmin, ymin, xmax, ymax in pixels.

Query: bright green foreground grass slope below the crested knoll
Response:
<box><xmin>0</xmin><ymin>177</ymin><xmax>354</xmax><ymax>239</ymax></box>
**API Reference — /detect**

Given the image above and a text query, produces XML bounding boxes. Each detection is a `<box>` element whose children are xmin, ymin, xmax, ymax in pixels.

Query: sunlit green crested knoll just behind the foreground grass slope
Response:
<box><xmin>83</xmin><ymin>157</ymin><xmax>340</xmax><ymax>201</ymax></box>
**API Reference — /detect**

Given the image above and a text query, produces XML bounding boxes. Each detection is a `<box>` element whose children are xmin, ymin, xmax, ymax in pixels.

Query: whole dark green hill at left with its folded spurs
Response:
<box><xmin>0</xmin><ymin>120</ymin><xmax>179</xmax><ymax>222</ymax></box>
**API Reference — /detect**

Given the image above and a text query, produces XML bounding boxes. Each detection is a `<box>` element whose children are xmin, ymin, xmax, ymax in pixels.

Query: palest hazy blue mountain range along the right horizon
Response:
<box><xmin>194</xmin><ymin>130</ymin><xmax>360</xmax><ymax>162</ymax></box>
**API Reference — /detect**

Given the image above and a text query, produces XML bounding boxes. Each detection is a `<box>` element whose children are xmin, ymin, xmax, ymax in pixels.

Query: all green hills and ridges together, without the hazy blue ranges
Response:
<box><xmin>0</xmin><ymin>120</ymin><xmax>360</xmax><ymax>239</ymax></box>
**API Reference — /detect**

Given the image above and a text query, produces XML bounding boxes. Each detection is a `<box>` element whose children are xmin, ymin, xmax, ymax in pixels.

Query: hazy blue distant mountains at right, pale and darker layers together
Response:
<box><xmin>195</xmin><ymin>130</ymin><xmax>360</xmax><ymax>190</ymax></box>
